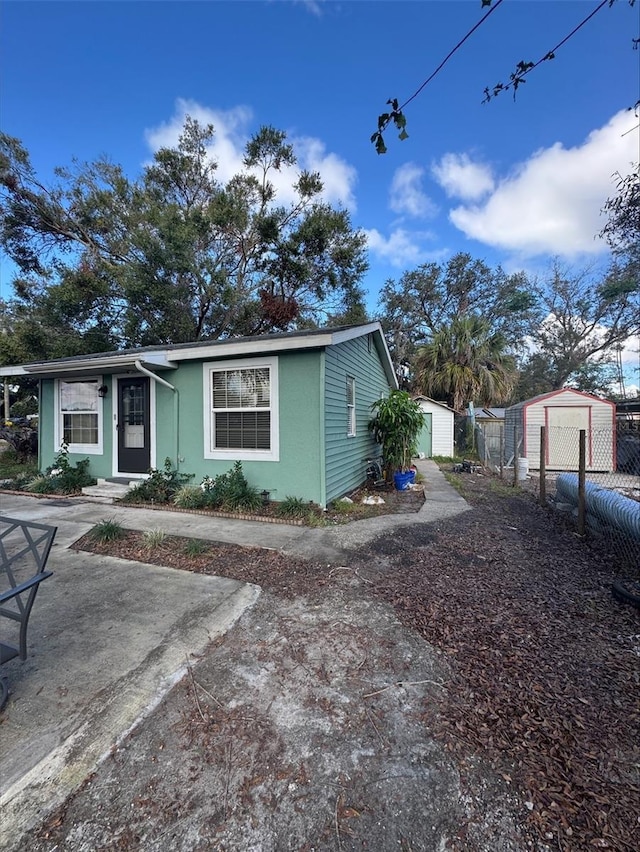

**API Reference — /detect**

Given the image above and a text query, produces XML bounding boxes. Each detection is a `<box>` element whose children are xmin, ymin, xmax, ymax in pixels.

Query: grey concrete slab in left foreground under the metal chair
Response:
<box><xmin>0</xmin><ymin>544</ymin><xmax>259</xmax><ymax>850</ymax></box>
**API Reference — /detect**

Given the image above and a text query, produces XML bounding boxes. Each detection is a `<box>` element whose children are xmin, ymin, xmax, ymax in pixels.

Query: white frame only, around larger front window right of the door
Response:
<box><xmin>202</xmin><ymin>357</ymin><xmax>280</xmax><ymax>461</ymax></box>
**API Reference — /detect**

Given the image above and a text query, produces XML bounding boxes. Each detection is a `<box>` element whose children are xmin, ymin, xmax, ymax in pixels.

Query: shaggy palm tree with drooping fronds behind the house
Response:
<box><xmin>415</xmin><ymin>316</ymin><xmax>517</xmax><ymax>411</ymax></box>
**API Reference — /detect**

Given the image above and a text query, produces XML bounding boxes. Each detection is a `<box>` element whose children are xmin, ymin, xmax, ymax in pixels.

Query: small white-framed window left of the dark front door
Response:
<box><xmin>56</xmin><ymin>379</ymin><xmax>102</xmax><ymax>453</ymax></box>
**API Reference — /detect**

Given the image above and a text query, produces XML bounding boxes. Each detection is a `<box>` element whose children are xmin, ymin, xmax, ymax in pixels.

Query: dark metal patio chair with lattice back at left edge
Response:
<box><xmin>0</xmin><ymin>515</ymin><xmax>57</xmax><ymax>710</ymax></box>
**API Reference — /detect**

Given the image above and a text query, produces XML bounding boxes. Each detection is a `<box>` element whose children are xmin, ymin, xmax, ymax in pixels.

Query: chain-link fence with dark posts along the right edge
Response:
<box><xmin>474</xmin><ymin>421</ymin><xmax>640</xmax><ymax>574</ymax></box>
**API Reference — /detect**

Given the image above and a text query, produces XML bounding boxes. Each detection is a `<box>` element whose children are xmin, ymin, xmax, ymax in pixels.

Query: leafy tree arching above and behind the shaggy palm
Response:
<box><xmin>379</xmin><ymin>253</ymin><xmax>543</xmax><ymax>376</ymax></box>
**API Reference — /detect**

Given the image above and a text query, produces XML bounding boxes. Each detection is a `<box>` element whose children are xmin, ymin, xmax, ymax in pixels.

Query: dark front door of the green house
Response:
<box><xmin>118</xmin><ymin>376</ymin><xmax>151</xmax><ymax>473</ymax></box>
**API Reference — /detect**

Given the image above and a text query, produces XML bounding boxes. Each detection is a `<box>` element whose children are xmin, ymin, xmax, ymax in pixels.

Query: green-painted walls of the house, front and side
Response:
<box><xmin>40</xmin><ymin>337</ymin><xmax>389</xmax><ymax>506</ymax></box>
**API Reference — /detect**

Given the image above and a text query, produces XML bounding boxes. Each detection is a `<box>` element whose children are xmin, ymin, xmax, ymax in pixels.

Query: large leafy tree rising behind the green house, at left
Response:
<box><xmin>0</xmin><ymin>118</ymin><xmax>367</xmax><ymax>351</ymax></box>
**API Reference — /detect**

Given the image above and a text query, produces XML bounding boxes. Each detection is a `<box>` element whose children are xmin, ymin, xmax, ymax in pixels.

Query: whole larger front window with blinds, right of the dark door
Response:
<box><xmin>205</xmin><ymin>359</ymin><xmax>278</xmax><ymax>461</ymax></box>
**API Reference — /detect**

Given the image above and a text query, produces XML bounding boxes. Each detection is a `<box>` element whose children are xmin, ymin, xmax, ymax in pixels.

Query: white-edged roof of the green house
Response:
<box><xmin>0</xmin><ymin>322</ymin><xmax>398</xmax><ymax>388</ymax></box>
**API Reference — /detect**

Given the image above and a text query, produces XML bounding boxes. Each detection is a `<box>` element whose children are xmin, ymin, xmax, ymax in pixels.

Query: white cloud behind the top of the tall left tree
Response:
<box><xmin>145</xmin><ymin>98</ymin><xmax>357</xmax><ymax>211</ymax></box>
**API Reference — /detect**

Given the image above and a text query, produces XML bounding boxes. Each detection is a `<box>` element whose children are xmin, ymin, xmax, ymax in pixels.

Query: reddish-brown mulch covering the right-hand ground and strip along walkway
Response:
<box><xmin>71</xmin><ymin>474</ymin><xmax>640</xmax><ymax>852</ymax></box>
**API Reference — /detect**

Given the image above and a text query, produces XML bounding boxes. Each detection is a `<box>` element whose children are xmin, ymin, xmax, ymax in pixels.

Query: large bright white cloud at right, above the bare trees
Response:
<box><xmin>450</xmin><ymin>111</ymin><xmax>638</xmax><ymax>257</ymax></box>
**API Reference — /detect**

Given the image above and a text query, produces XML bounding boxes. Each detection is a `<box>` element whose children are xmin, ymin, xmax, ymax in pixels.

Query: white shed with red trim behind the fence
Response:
<box><xmin>504</xmin><ymin>388</ymin><xmax>616</xmax><ymax>471</ymax></box>
